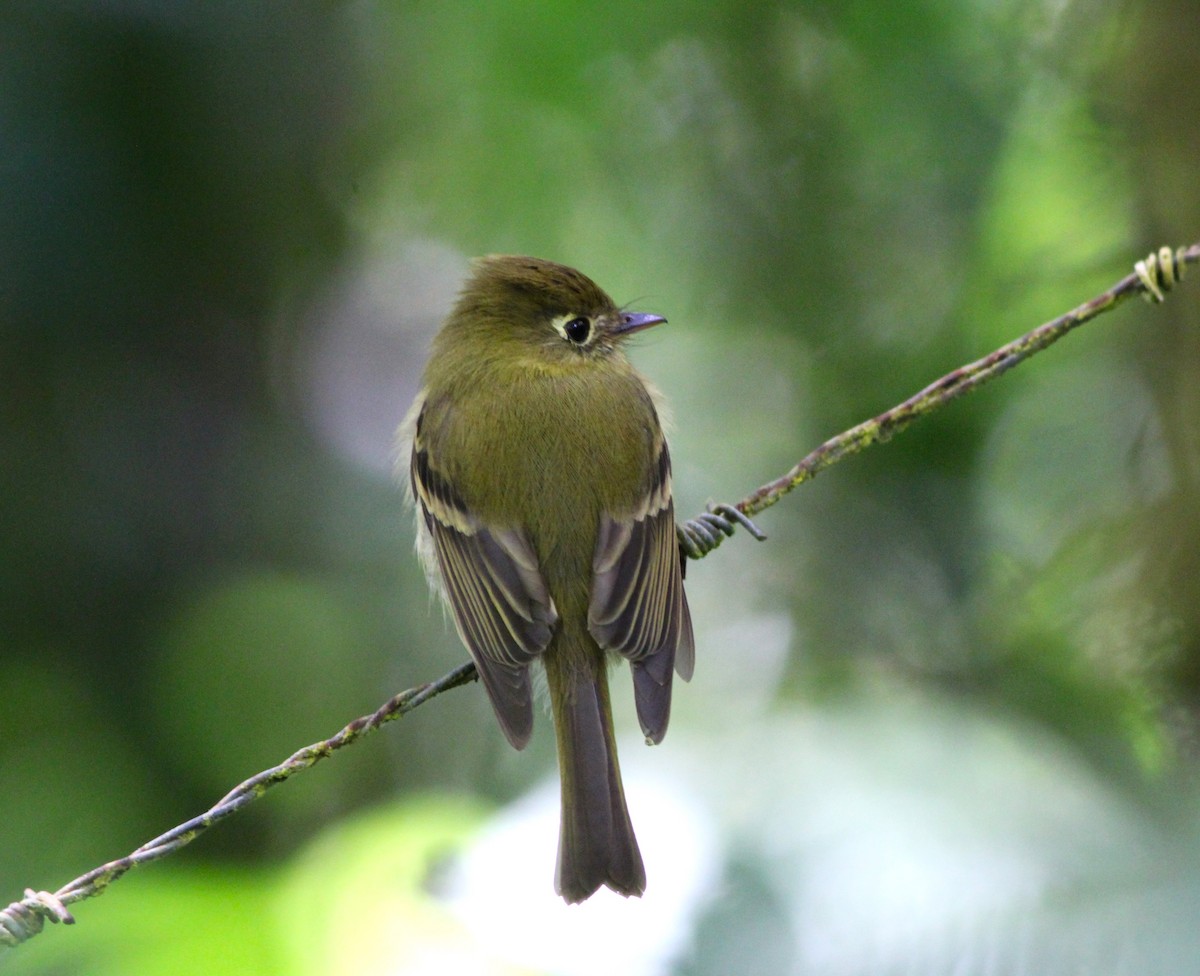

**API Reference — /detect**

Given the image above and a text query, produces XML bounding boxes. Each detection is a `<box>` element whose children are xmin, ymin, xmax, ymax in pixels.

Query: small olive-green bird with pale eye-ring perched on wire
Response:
<box><xmin>408</xmin><ymin>256</ymin><xmax>695</xmax><ymax>903</ymax></box>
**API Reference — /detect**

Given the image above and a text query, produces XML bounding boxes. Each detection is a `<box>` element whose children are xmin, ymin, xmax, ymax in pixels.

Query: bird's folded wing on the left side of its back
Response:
<box><xmin>409</xmin><ymin>403</ymin><xmax>558</xmax><ymax>749</ymax></box>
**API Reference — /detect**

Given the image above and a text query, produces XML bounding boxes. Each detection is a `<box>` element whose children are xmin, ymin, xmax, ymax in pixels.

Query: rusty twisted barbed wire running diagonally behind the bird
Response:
<box><xmin>0</xmin><ymin>244</ymin><xmax>1200</xmax><ymax>952</ymax></box>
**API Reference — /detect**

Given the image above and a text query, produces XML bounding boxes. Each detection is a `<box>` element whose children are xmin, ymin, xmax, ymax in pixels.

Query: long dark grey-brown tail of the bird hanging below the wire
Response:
<box><xmin>547</xmin><ymin>661</ymin><xmax>646</xmax><ymax>904</ymax></box>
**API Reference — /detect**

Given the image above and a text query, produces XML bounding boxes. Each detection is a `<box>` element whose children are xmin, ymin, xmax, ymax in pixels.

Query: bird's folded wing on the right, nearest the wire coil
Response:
<box><xmin>588</xmin><ymin>435</ymin><xmax>695</xmax><ymax>742</ymax></box>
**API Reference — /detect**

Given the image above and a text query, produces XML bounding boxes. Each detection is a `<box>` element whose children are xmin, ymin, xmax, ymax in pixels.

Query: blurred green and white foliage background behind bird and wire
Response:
<box><xmin>7</xmin><ymin>0</ymin><xmax>1200</xmax><ymax>976</ymax></box>
